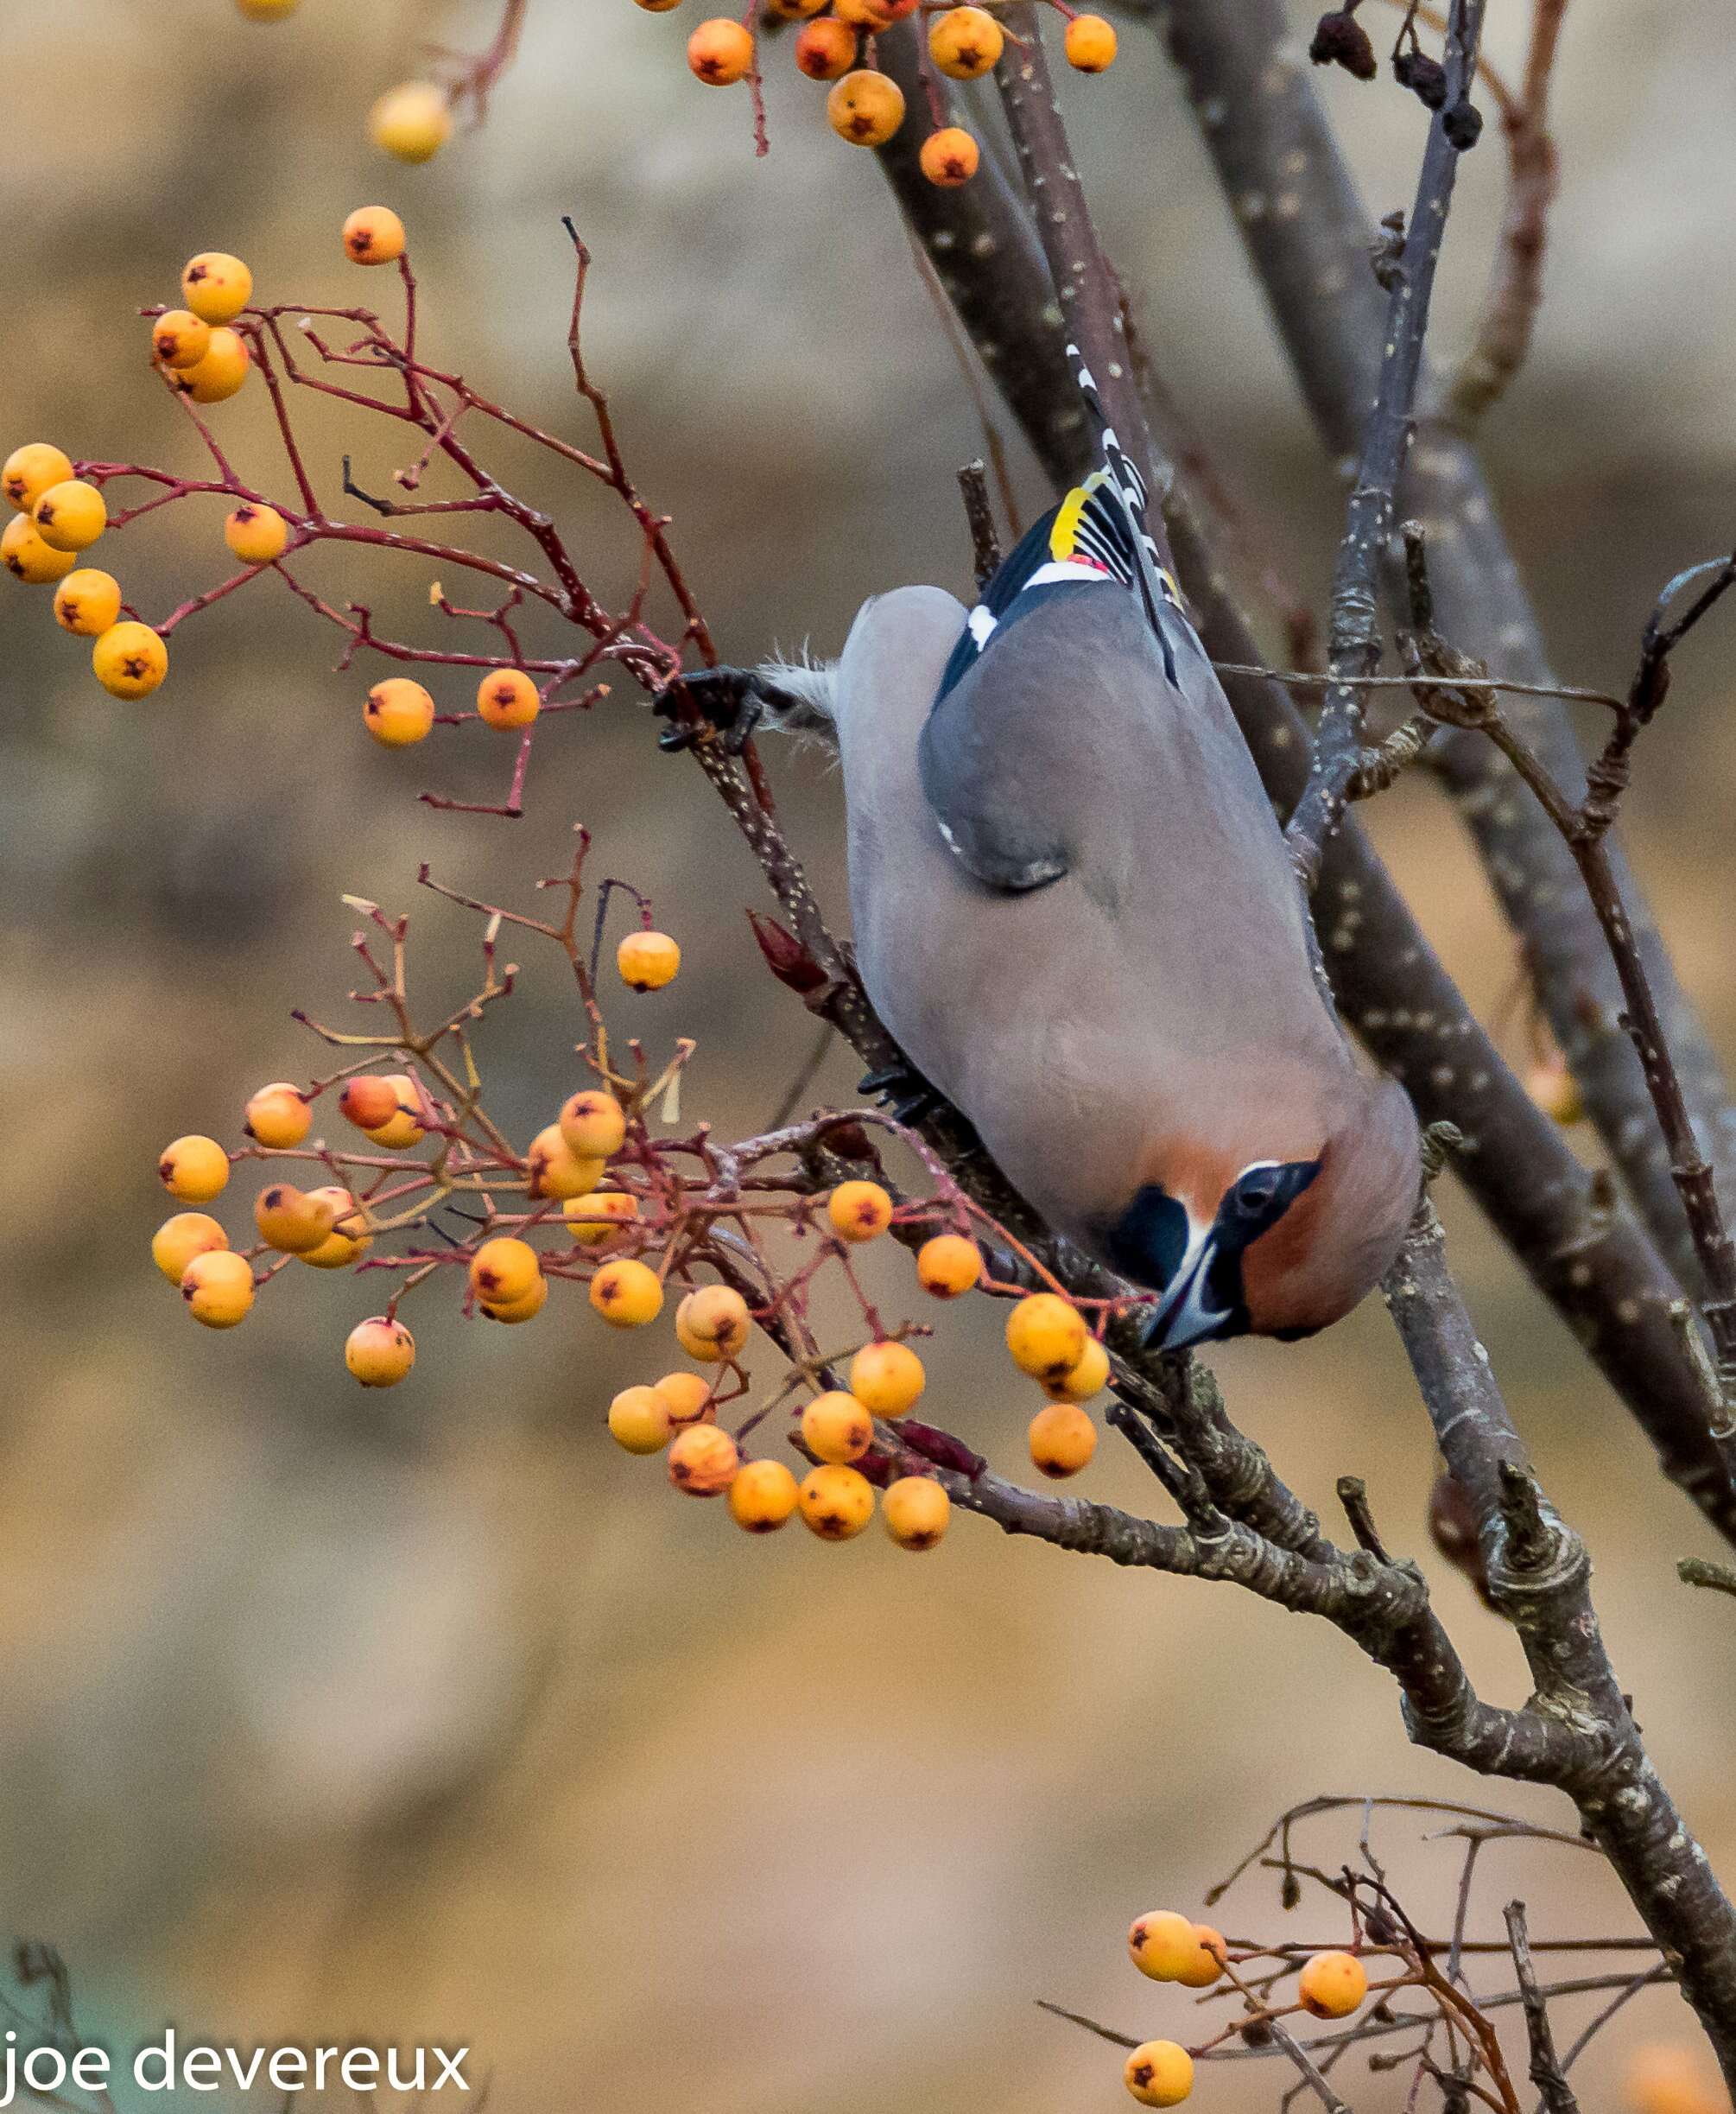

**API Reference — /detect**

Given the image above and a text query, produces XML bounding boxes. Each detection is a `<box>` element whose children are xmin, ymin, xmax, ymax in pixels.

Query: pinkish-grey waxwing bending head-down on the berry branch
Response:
<box><xmin>672</xmin><ymin>344</ymin><xmax>1419</xmax><ymax>1349</ymax></box>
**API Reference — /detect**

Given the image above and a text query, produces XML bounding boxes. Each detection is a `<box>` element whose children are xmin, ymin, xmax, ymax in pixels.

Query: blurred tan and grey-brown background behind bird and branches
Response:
<box><xmin>0</xmin><ymin>0</ymin><xmax>1736</xmax><ymax>2114</ymax></box>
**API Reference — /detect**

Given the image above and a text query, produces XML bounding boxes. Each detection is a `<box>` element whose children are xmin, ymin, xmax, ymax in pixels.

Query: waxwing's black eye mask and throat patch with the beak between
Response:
<box><xmin>1104</xmin><ymin>1160</ymin><xmax>1320</xmax><ymax>1351</ymax></box>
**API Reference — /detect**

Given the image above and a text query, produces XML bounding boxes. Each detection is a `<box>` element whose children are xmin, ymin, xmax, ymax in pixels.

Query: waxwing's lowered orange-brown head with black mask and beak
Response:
<box><xmin>1104</xmin><ymin>1078</ymin><xmax>1419</xmax><ymax>1351</ymax></box>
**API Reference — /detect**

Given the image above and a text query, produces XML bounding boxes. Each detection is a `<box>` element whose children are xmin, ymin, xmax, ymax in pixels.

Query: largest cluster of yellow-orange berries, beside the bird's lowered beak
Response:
<box><xmin>152</xmin><ymin>833</ymin><xmax>1108</xmax><ymax>1550</ymax></box>
